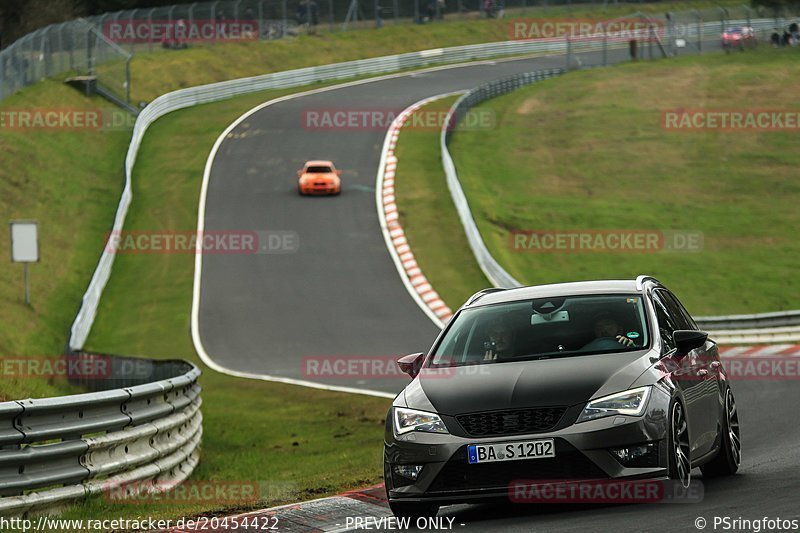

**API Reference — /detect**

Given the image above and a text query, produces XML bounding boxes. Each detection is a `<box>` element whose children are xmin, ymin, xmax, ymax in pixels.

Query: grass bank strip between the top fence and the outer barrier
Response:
<box><xmin>125</xmin><ymin>0</ymin><xmax>742</xmax><ymax>102</ymax></box>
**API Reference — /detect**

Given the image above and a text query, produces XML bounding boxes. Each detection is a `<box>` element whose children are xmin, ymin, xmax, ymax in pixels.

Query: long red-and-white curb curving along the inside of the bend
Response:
<box><xmin>375</xmin><ymin>93</ymin><xmax>461</xmax><ymax>328</ymax></box>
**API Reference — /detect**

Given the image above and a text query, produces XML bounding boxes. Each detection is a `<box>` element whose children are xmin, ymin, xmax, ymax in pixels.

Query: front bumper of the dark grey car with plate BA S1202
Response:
<box><xmin>384</xmin><ymin>386</ymin><xmax>669</xmax><ymax>504</ymax></box>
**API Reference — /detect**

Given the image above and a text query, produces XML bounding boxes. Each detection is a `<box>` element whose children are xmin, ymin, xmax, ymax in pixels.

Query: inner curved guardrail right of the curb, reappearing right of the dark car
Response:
<box><xmin>440</xmin><ymin>69</ymin><xmax>800</xmax><ymax>344</ymax></box>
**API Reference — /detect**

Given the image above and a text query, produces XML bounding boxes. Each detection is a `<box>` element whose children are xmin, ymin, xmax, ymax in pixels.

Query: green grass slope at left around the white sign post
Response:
<box><xmin>0</xmin><ymin>81</ymin><xmax>130</xmax><ymax>401</ymax></box>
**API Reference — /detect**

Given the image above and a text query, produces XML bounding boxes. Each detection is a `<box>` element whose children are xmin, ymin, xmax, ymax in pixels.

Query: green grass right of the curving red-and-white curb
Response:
<box><xmin>398</xmin><ymin>47</ymin><xmax>800</xmax><ymax>315</ymax></box>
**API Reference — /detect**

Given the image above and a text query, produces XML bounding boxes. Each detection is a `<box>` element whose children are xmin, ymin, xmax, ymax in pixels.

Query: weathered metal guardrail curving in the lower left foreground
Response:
<box><xmin>0</xmin><ymin>353</ymin><xmax>203</xmax><ymax>516</ymax></box>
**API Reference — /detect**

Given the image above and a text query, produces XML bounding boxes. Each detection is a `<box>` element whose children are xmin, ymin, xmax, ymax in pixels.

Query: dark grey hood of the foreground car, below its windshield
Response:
<box><xmin>405</xmin><ymin>351</ymin><xmax>657</xmax><ymax>416</ymax></box>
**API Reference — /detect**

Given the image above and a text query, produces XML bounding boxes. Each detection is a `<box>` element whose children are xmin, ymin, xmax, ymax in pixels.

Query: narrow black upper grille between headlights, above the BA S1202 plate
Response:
<box><xmin>456</xmin><ymin>407</ymin><xmax>567</xmax><ymax>437</ymax></box>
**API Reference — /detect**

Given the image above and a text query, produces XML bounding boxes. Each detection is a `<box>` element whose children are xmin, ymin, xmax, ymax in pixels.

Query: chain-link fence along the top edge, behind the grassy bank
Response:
<box><xmin>0</xmin><ymin>0</ymin><xmax>786</xmax><ymax>107</ymax></box>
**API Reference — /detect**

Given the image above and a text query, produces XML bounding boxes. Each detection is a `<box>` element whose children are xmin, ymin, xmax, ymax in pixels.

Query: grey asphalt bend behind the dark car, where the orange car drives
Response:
<box><xmin>199</xmin><ymin>45</ymin><xmax>640</xmax><ymax>393</ymax></box>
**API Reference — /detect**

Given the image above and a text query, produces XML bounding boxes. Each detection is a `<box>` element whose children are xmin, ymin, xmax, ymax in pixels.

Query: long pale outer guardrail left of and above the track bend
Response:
<box><xmin>69</xmin><ymin>19</ymin><xmax>774</xmax><ymax>350</ymax></box>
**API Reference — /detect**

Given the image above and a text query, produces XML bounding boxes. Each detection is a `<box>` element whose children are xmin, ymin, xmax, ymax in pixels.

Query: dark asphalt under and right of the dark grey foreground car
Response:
<box><xmin>446</xmin><ymin>380</ymin><xmax>800</xmax><ymax>533</ymax></box>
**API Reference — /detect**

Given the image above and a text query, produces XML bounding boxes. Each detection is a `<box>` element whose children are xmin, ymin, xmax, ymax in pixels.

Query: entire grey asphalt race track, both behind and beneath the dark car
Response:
<box><xmin>192</xmin><ymin>43</ymin><xmax>800</xmax><ymax>532</ymax></box>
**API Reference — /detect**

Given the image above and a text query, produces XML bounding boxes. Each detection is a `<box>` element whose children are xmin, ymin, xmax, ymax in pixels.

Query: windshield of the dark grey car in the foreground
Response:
<box><xmin>429</xmin><ymin>294</ymin><xmax>649</xmax><ymax>366</ymax></box>
